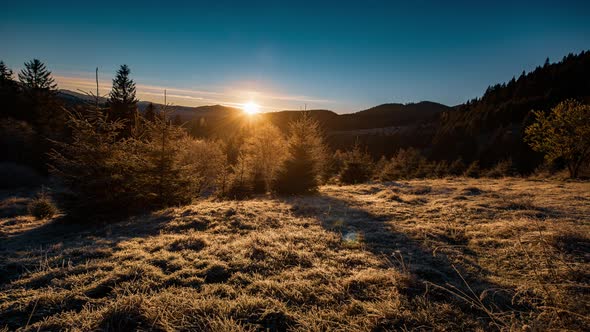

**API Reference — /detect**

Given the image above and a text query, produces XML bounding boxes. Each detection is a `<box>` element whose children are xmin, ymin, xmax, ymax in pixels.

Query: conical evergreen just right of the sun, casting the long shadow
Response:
<box><xmin>274</xmin><ymin>114</ymin><xmax>326</xmax><ymax>194</ymax></box>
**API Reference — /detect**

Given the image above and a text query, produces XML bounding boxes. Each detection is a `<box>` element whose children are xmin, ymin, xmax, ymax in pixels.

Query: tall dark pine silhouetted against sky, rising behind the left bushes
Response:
<box><xmin>109</xmin><ymin>65</ymin><xmax>138</xmax><ymax>135</ymax></box>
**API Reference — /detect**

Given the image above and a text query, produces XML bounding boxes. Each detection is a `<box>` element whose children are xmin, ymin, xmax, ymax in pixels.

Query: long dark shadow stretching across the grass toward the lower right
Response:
<box><xmin>282</xmin><ymin>194</ymin><xmax>526</xmax><ymax>320</ymax></box>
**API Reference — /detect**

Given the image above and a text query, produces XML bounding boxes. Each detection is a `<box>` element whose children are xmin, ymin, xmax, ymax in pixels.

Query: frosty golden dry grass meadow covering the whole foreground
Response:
<box><xmin>0</xmin><ymin>178</ymin><xmax>590</xmax><ymax>331</ymax></box>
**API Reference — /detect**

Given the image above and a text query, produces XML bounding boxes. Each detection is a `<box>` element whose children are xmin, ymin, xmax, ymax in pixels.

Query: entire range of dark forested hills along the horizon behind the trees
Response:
<box><xmin>55</xmin><ymin>51</ymin><xmax>590</xmax><ymax>172</ymax></box>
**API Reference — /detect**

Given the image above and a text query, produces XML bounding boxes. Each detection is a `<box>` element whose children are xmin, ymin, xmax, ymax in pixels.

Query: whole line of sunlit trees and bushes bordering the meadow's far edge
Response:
<box><xmin>0</xmin><ymin>60</ymin><xmax>590</xmax><ymax>219</ymax></box>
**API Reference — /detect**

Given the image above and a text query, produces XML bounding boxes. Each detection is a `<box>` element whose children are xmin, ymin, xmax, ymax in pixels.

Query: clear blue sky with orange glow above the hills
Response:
<box><xmin>0</xmin><ymin>0</ymin><xmax>590</xmax><ymax>112</ymax></box>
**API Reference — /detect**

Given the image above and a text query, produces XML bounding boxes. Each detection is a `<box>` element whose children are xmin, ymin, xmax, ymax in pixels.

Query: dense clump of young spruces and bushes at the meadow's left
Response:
<box><xmin>51</xmin><ymin>110</ymin><xmax>223</xmax><ymax>215</ymax></box>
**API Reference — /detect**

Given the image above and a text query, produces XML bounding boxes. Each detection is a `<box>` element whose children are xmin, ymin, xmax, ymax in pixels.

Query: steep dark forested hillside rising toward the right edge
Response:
<box><xmin>431</xmin><ymin>51</ymin><xmax>590</xmax><ymax>171</ymax></box>
